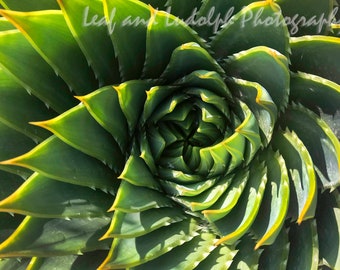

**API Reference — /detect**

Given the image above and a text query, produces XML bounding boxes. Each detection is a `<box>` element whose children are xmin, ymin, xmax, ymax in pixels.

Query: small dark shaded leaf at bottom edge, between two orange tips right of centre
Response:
<box><xmin>259</xmin><ymin>228</ymin><xmax>289</xmax><ymax>270</ymax></box>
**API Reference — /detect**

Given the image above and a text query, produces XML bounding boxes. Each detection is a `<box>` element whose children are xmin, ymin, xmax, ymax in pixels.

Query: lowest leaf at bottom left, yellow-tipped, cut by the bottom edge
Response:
<box><xmin>27</xmin><ymin>250</ymin><xmax>107</xmax><ymax>270</ymax></box>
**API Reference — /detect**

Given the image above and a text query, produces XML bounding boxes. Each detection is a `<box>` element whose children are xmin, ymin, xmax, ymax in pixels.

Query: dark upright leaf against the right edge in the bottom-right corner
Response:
<box><xmin>316</xmin><ymin>190</ymin><xmax>340</xmax><ymax>269</ymax></box>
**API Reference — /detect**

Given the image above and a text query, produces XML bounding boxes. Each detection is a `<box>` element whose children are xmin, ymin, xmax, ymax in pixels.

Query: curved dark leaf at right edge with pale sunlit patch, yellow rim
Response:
<box><xmin>282</xmin><ymin>105</ymin><xmax>340</xmax><ymax>190</ymax></box>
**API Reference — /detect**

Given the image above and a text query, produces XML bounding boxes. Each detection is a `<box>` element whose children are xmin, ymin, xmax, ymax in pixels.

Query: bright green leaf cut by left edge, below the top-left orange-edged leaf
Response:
<box><xmin>0</xmin><ymin>30</ymin><xmax>75</xmax><ymax>113</ymax></box>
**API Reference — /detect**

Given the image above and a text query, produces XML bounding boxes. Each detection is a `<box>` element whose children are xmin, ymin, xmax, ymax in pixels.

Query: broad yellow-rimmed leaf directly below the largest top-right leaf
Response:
<box><xmin>224</xmin><ymin>46</ymin><xmax>289</xmax><ymax>111</ymax></box>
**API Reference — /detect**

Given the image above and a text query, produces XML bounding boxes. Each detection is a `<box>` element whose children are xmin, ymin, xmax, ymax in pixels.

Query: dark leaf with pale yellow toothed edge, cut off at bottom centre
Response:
<box><xmin>134</xmin><ymin>233</ymin><xmax>216</xmax><ymax>270</ymax></box>
